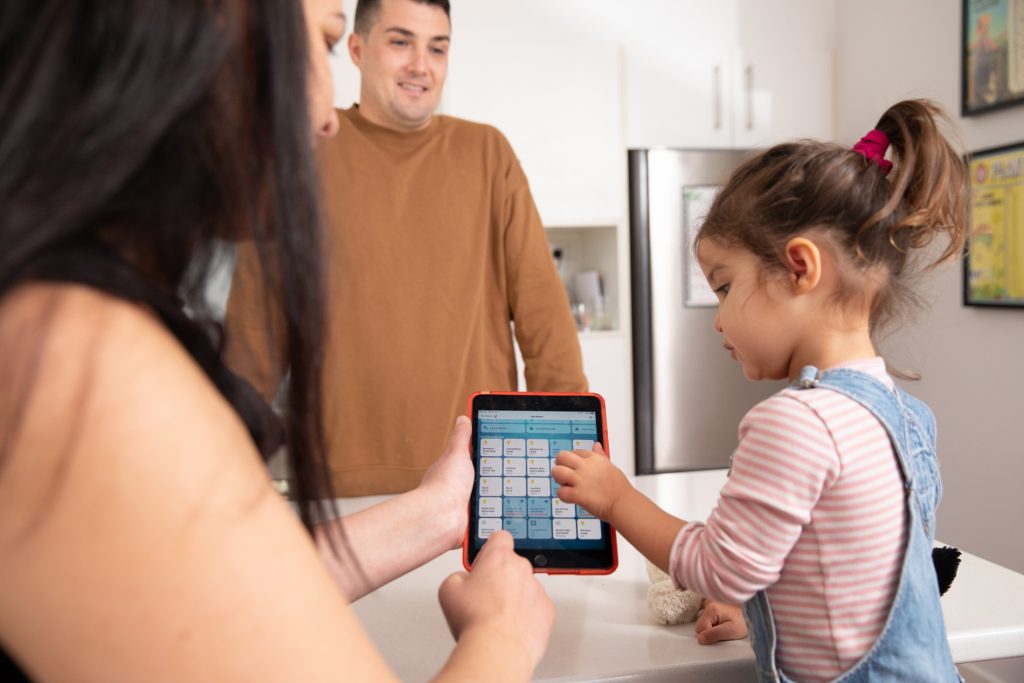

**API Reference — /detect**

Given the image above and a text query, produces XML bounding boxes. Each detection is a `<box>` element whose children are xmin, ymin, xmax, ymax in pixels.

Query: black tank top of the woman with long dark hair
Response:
<box><xmin>0</xmin><ymin>241</ymin><xmax>285</xmax><ymax>683</ymax></box>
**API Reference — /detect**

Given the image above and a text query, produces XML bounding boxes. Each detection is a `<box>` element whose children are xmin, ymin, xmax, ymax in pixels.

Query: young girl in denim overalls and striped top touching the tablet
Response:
<box><xmin>553</xmin><ymin>101</ymin><xmax>966</xmax><ymax>681</ymax></box>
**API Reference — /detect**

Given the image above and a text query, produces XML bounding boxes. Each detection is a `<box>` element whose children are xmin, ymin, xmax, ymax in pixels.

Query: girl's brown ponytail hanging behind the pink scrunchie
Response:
<box><xmin>855</xmin><ymin>99</ymin><xmax>967</xmax><ymax>271</ymax></box>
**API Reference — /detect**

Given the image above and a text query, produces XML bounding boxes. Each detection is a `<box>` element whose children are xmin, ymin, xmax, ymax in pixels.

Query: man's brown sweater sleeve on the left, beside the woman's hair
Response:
<box><xmin>224</xmin><ymin>242</ymin><xmax>287</xmax><ymax>402</ymax></box>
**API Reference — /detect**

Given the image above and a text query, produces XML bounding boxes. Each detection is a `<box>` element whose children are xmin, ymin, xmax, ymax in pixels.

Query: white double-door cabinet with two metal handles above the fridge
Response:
<box><xmin>624</xmin><ymin>0</ymin><xmax>835</xmax><ymax>148</ymax></box>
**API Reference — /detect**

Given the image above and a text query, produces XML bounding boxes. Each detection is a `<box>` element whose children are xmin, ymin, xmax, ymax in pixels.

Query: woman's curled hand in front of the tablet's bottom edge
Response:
<box><xmin>437</xmin><ymin>531</ymin><xmax>555</xmax><ymax>670</ymax></box>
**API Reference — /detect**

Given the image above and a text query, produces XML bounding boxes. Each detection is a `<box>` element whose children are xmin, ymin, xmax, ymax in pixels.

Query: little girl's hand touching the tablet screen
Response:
<box><xmin>551</xmin><ymin>443</ymin><xmax>633</xmax><ymax>523</ymax></box>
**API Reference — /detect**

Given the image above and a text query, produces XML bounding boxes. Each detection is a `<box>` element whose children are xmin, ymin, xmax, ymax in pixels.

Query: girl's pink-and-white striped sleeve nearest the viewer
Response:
<box><xmin>669</xmin><ymin>393</ymin><xmax>840</xmax><ymax>603</ymax></box>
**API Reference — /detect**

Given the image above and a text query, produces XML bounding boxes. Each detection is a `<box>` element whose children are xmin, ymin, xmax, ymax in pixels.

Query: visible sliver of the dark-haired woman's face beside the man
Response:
<box><xmin>302</xmin><ymin>0</ymin><xmax>345</xmax><ymax>138</ymax></box>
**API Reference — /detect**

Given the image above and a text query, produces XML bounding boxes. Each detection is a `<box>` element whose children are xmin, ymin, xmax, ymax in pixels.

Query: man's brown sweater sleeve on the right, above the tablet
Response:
<box><xmin>502</xmin><ymin>140</ymin><xmax>587</xmax><ymax>391</ymax></box>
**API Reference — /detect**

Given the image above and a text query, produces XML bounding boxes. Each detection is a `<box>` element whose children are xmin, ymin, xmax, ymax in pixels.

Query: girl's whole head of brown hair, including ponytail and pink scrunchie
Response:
<box><xmin>697</xmin><ymin>100</ymin><xmax>967</xmax><ymax>332</ymax></box>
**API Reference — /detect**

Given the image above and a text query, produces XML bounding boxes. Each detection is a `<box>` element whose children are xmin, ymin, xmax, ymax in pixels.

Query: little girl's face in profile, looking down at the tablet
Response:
<box><xmin>697</xmin><ymin>240</ymin><xmax>802</xmax><ymax>380</ymax></box>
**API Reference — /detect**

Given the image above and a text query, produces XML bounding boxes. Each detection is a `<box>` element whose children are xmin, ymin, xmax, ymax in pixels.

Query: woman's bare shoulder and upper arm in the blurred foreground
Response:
<box><xmin>0</xmin><ymin>286</ymin><xmax>388</xmax><ymax>681</ymax></box>
